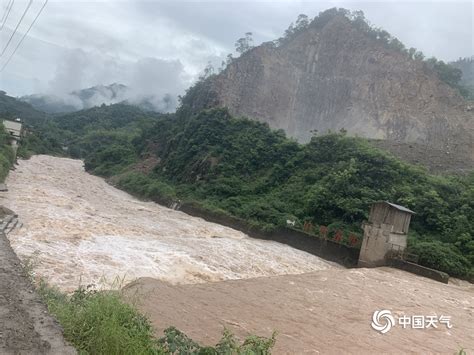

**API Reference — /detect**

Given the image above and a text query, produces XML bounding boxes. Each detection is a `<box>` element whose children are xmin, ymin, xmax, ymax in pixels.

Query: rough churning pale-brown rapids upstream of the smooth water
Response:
<box><xmin>0</xmin><ymin>155</ymin><xmax>337</xmax><ymax>291</ymax></box>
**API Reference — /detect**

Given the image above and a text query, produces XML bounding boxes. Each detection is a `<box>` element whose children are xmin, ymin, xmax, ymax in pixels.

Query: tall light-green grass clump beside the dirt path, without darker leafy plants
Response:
<box><xmin>39</xmin><ymin>282</ymin><xmax>160</xmax><ymax>354</ymax></box>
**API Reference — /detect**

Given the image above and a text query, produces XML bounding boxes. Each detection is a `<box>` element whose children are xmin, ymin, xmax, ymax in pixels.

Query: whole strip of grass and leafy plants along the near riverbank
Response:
<box><xmin>38</xmin><ymin>281</ymin><xmax>275</xmax><ymax>355</ymax></box>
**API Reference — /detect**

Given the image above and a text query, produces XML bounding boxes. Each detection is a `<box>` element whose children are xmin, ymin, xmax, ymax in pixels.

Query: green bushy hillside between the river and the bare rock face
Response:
<box><xmin>16</xmin><ymin>101</ymin><xmax>474</xmax><ymax>277</ymax></box>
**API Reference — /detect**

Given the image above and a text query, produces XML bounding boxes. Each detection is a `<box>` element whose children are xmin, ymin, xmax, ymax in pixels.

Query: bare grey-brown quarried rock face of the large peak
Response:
<box><xmin>194</xmin><ymin>16</ymin><xmax>474</xmax><ymax>165</ymax></box>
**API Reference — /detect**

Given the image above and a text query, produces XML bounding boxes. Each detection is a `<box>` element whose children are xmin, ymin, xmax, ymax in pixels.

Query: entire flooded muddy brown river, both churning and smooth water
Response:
<box><xmin>0</xmin><ymin>156</ymin><xmax>474</xmax><ymax>354</ymax></box>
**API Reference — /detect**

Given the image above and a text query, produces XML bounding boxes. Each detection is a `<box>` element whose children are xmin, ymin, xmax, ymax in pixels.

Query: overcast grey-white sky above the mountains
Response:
<box><xmin>0</xmin><ymin>0</ymin><xmax>474</xmax><ymax>96</ymax></box>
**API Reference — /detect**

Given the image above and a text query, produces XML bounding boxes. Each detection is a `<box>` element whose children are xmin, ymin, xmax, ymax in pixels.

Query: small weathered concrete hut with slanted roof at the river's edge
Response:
<box><xmin>359</xmin><ymin>201</ymin><xmax>415</xmax><ymax>267</ymax></box>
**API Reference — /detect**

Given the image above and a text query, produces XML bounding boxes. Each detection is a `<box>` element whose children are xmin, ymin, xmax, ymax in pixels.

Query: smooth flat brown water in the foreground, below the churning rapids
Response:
<box><xmin>126</xmin><ymin>268</ymin><xmax>474</xmax><ymax>355</ymax></box>
